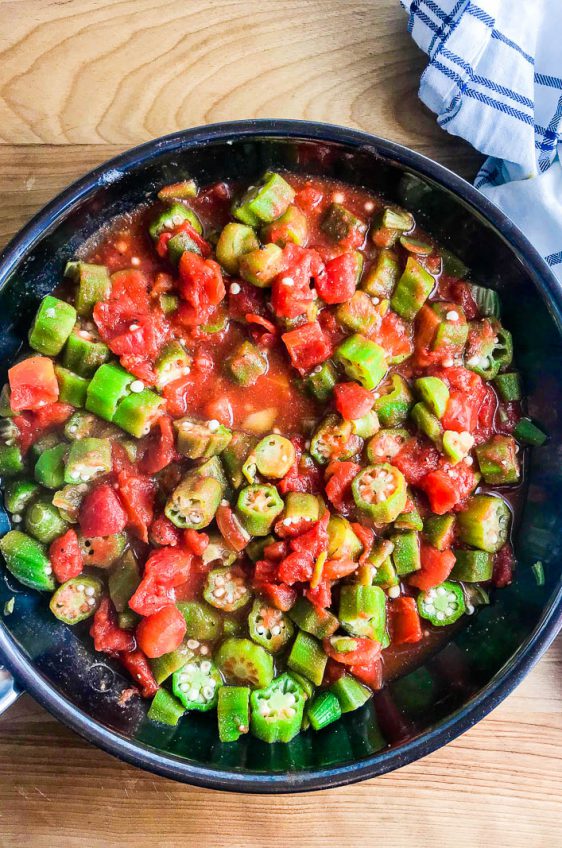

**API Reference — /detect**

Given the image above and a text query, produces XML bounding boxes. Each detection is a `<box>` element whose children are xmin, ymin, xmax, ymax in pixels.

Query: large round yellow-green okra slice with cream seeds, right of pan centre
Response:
<box><xmin>351</xmin><ymin>462</ymin><xmax>408</xmax><ymax>524</ymax></box>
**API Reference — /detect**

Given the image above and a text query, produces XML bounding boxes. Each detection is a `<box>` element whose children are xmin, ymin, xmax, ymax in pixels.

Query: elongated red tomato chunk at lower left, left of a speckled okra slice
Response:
<box><xmin>129</xmin><ymin>547</ymin><xmax>193</xmax><ymax>615</ymax></box>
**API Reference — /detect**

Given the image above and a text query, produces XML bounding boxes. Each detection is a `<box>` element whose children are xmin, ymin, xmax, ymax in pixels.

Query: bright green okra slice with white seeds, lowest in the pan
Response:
<box><xmin>250</xmin><ymin>674</ymin><xmax>306</xmax><ymax>743</ymax></box>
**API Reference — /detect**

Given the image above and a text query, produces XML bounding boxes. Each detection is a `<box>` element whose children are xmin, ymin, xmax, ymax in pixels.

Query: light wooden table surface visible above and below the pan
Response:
<box><xmin>0</xmin><ymin>0</ymin><xmax>562</xmax><ymax>848</ymax></box>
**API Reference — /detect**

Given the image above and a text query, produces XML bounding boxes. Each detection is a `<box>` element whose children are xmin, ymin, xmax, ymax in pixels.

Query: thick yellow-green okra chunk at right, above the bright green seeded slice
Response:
<box><xmin>457</xmin><ymin>495</ymin><xmax>511</xmax><ymax>554</ymax></box>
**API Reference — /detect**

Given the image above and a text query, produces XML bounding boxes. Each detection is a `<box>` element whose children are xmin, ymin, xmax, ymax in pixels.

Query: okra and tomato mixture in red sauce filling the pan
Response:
<box><xmin>0</xmin><ymin>172</ymin><xmax>546</xmax><ymax>742</ymax></box>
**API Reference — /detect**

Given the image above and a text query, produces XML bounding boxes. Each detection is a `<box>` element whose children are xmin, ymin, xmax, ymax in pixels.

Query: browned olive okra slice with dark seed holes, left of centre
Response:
<box><xmin>164</xmin><ymin>469</ymin><xmax>223</xmax><ymax>530</ymax></box>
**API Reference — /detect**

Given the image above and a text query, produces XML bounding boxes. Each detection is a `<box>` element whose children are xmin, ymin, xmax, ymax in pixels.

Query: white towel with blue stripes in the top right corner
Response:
<box><xmin>401</xmin><ymin>0</ymin><xmax>562</xmax><ymax>282</ymax></box>
